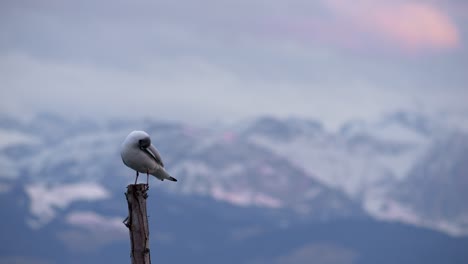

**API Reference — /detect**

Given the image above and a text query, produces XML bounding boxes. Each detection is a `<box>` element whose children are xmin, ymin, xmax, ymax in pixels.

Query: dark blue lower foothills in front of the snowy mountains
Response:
<box><xmin>0</xmin><ymin>184</ymin><xmax>468</xmax><ymax>264</ymax></box>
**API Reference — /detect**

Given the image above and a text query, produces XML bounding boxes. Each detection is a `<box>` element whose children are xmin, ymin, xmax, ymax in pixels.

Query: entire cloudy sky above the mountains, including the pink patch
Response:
<box><xmin>0</xmin><ymin>0</ymin><xmax>468</xmax><ymax>126</ymax></box>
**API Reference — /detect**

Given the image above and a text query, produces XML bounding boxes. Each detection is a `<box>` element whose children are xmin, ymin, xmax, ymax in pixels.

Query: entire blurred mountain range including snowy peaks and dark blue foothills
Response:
<box><xmin>0</xmin><ymin>111</ymin><xmax>468</xmax><ymax>263</ymax></box>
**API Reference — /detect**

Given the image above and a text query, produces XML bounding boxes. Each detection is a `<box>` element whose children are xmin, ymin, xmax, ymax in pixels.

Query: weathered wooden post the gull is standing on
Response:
<box><xmin>124</xmin><ymin>184</ymin><xmax>151</xmax><ymax>264</ymax></box>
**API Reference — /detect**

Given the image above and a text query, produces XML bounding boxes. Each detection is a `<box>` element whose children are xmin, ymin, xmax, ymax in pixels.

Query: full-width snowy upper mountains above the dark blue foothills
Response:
<box><xmin>0</xmin><ymin>109</ymin><xmax>468</xmax><ymax>235</ymax></box>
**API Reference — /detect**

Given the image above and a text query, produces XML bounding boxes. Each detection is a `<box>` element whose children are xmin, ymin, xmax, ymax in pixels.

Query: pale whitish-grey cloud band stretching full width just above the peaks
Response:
<box><xmin>0</xmin><ymin>50</ymin><xmax>466</xmax><ymax>128</ymax></box>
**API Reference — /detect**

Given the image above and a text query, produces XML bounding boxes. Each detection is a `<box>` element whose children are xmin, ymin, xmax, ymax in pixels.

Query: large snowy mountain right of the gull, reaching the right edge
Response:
<box><xmin>236</xmin><ymin>112</ymin><xmax>468</xmax><ymax>235</ymax></box>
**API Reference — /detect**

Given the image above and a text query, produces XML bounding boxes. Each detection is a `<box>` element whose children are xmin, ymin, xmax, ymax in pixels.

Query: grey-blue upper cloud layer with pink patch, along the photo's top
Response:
<box><xmin>0</xmin><ymin>0</ymin><xmax>460</xmax><ymax>61</ymax></box>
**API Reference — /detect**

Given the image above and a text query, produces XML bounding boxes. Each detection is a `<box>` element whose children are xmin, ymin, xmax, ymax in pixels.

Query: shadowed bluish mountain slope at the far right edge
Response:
<box><xmin>380</xmin><ymin>132</ymin><xmax>468</xmax><ymax>234</ymax></box>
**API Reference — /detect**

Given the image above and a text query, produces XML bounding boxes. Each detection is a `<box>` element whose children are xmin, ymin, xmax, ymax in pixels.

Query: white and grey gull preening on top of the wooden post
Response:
<box><xmin>120</xmin><ymin>131</ymin><xmax>177</xmax><ymax>184</ymax></box>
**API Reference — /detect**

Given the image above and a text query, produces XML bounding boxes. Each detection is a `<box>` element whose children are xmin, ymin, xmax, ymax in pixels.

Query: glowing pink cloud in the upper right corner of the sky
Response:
<box><xmin>315</xmin><ymin>0</ymin><xmax>460</xmax><ymax>52</ymax></box>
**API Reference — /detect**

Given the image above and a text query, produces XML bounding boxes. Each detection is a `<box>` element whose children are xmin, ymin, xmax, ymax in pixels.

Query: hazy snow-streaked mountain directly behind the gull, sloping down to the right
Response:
<box><xmin>0</xmin><ymin>112</ymin><xmax>362</xmax><ymax>226</ymax></box>
